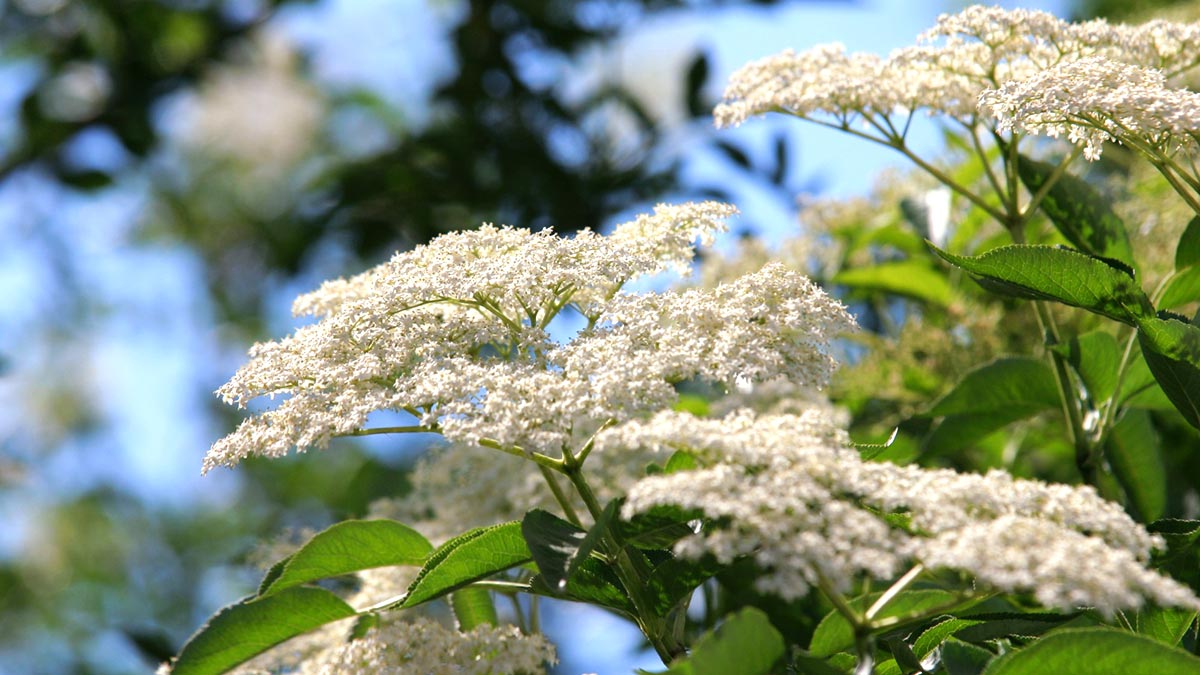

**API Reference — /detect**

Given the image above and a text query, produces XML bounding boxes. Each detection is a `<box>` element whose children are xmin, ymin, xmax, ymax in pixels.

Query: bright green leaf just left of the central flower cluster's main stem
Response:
<box><xmin>400</xmin><ymin>520</ymin><xmax>533</xmax><ymax>608</ymax></box>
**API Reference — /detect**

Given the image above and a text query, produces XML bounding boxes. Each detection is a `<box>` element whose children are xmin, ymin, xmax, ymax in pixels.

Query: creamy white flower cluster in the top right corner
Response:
<box><xmin>714</xmin><ymin>6</ymin><xmax>1200</xmax><ymax>142</ymax></box>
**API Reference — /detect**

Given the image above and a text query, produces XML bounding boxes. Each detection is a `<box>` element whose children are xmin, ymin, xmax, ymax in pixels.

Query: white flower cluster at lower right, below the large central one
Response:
<box><xmin>619</xmin><ymin>411</ymin><xmax>1200</xmax><ymax>614</ymax></box>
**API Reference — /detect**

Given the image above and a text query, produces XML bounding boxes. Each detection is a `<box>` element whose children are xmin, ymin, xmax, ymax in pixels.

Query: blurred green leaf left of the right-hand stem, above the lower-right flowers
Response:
<box><xmin>922</xmin><ymin>357</ymin><xmax>1058</xmax><ymax>454</ymax></box>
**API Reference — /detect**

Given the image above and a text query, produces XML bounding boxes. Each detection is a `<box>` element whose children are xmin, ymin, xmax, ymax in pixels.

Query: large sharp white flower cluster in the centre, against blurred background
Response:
<box><xmin>204</xmin><ymin>202</ymin><xmax>853</xmax><ymax>471</ymax></box>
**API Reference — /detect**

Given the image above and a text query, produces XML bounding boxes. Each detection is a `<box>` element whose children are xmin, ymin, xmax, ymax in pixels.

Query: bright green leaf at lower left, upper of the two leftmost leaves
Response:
<box><xmin>258</xmin><ymin>520</ymin><xmax>433</xmax><ymax>596</ymax></box>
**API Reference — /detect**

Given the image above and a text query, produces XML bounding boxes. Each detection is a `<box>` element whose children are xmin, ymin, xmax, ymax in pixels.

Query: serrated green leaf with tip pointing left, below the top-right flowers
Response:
<box><xmin>930</xmin><ymin>244</ymin><xmax>1154</xmax><ymax>325</ymax></box>
